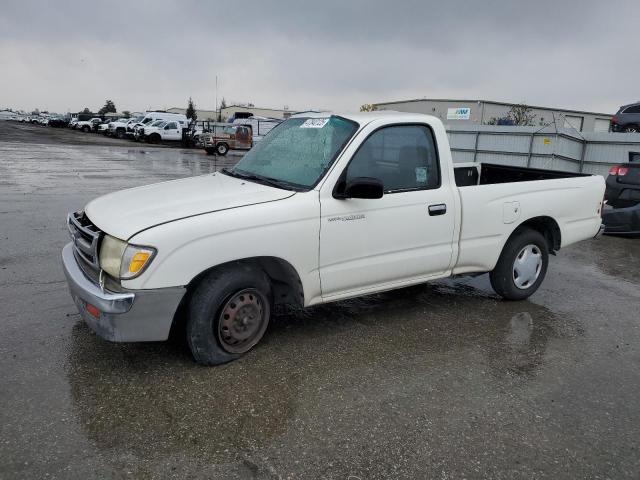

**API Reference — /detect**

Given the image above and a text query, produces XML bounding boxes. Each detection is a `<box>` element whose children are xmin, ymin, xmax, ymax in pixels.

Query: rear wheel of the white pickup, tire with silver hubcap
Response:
<box><xmin>489</xmin><ymin>227</ymin><xmax>549</xmax><ymax>300</ymax></box>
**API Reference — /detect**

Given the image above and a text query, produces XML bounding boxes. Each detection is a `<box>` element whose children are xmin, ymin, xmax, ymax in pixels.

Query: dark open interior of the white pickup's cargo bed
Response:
<box><xmin>454</xmin><ymin>163</ymin><xmax>589</xmax><ymax>187</ymax></box>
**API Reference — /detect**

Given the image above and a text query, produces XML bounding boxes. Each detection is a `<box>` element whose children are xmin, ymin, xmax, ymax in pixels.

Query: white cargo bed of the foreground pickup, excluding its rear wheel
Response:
<box><xmin>453</xmin><ymin>163</ymin><xmax>604</xmax><ymax>274</ymax></box>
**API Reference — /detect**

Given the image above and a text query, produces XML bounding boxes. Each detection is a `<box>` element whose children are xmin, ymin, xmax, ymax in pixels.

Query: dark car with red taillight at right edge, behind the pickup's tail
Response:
<box><xmin>602</xmin><ymin>152</ymin><xmax>640</xmax><ymax>235</ymax></box>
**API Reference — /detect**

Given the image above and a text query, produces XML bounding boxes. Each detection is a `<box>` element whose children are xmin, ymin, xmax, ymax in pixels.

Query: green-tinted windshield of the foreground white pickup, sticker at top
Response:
<box><xmin>229</xmin><ymin>115</ymin><xmax>358</xmax><ymax>190</ymax></box>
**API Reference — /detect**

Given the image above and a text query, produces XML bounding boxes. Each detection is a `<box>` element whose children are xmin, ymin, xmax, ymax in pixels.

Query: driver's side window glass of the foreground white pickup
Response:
<box><xmin>346</xmin><ymin>125</ymin><xmax>440</xmax><ymax>193</ymax></box>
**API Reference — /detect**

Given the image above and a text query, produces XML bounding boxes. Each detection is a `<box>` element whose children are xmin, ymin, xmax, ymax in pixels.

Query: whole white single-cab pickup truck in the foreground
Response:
<box><xmin>62</xmin><ymin>112</ymin><xmax>605</xmax><ymax>365</ymax></box>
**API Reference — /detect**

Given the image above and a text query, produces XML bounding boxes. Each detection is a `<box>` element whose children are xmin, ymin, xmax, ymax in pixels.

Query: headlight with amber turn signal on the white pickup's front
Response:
<box><xmin>100</xmin><ymin>235</ymin><xmax>156</xmax><ymax>280</ymax></box>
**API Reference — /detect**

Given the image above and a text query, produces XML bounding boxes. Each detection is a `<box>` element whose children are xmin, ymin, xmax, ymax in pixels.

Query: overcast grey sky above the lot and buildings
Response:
<box><xmin>0</xmin><ymin>0</ymin><xmax>640</xmax><ymax>113</ymax></box>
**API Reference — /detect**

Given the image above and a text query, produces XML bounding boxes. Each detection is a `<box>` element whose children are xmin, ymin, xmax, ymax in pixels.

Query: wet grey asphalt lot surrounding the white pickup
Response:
<box><xmin>0</xmin><ymin>122</ymin><xmax>640</xmax><ymax>479</ymax></box>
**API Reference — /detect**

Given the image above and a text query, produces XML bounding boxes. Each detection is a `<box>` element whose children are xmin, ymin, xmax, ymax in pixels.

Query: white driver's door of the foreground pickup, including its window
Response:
<box><xmin>319</xmin><ymin>124</ymin><xmax>455</xmax><ymax>297</ymax></box>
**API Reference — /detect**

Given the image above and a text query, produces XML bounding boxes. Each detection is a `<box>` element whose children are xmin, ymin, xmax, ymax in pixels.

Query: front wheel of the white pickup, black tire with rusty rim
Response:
<box><xmin>186</xmin><ymin>264</ymin><xmax>272</xmax><ymax>365</ymax></box>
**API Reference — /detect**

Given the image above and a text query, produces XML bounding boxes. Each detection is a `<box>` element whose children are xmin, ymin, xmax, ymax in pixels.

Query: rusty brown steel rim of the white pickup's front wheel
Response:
<box><xmin>218</xmin><ymin>288</ymin><xmax>269</xmax><ymax>353</ymax></box>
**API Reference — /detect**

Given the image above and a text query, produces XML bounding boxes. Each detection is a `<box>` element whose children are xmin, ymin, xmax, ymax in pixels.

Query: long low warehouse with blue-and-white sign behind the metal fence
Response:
<box><xmin>374</xmin><ymin>98</ymin><xmax>612</xmax><ymax>132</ymax></box>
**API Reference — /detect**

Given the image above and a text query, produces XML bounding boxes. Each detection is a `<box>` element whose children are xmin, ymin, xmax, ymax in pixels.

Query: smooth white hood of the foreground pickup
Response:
<box><xmin>85</xmin><ymin>173</ymin><xmax>295</xmax><ymax>240</ymax></box>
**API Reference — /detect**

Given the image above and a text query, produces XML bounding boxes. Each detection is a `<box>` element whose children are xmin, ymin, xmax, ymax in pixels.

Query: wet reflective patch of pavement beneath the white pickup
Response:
<box><xmin>67</xmin><ymin>281</ymin><xmax>581</xmax><ymax>462</ymax></box>
